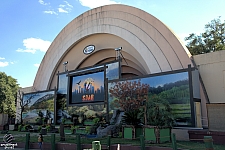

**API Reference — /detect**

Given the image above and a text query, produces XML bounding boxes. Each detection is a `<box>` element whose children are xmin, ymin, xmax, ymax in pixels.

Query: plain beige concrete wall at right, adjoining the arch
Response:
<box><xmin>194</xmin><ymin>50</ymin><xmax>225</xmax><ymax>103</ymax></box>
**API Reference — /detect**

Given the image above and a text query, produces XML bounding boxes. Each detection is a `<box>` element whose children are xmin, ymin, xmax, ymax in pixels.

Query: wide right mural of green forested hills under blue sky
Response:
<box><xmin>108</xmin><ymin>72</ymin><xmax>192</xmax><ymax>126</ymax></box>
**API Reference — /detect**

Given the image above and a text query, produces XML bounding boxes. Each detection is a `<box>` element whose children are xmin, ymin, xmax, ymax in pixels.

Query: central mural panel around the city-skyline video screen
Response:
<box><xmin>56</xmin><ymin>61</ymin><xmax>119</xmax><ymax>124</ymax></box>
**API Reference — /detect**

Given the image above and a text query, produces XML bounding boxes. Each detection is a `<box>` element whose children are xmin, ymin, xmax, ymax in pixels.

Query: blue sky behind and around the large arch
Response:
<box><xmin>0</xmin><ymin>0</ymin><xmax>225</xmax><ymax>87</ymax></box>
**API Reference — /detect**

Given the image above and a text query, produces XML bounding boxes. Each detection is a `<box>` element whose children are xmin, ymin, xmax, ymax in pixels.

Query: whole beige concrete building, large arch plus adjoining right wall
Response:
<box><xmin>16</xmin><ymin>4</ymin><xmax>225</xmax><ymax>139</ymax></box>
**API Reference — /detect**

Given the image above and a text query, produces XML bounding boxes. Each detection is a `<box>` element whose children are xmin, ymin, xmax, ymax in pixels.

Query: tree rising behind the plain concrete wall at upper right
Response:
<box><xmin>185</xmin><ymin>17</ymin><xmax>225</xmax><ymax>55</ymax></box>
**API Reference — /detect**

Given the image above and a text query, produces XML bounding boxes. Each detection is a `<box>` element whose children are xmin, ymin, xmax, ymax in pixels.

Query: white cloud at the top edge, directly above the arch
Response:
<box><xmin>79</xmin><ymin>0</ymin><xmax>120</xmax><ymax>8</ymax></box>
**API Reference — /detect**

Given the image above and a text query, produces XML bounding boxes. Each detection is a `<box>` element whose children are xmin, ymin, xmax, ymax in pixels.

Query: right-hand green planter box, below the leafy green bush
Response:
<box><xmin>143</xmin><ymin>126</ymin><xmax>171</xmax><ymax>143</ymax></box>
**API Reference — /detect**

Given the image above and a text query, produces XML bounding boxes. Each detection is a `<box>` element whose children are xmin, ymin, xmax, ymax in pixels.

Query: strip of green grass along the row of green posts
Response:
<box><xmin>2</xmin><ymin>131</ymin><xmax>225</xmax><ymax>150</ymax></box>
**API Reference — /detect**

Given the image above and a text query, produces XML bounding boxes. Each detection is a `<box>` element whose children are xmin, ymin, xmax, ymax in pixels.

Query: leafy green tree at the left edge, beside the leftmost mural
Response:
<box><xmin>0</xmin><ymin>72</ymin><xmax>19</xmax><ymax>117</ymax></box>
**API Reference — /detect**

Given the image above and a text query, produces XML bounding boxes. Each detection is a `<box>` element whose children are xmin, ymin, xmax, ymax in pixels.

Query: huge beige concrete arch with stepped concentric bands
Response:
<box><xmin>33</xmin><ymin>4</ymin><xmax>192</xmax><ymax>90</ymax></box>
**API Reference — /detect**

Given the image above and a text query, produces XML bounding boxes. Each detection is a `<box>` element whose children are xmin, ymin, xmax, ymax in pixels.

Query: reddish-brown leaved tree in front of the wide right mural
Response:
<box><xmin>109</xmin><ymin>80</ymin><xmax>149</xmax><ymax>125</ymax></box>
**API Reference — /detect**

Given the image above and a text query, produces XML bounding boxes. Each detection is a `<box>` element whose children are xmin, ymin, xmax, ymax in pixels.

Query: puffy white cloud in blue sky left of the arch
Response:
<box><xmin>16</xmin><ymin>38</ymin><xmax>51</xmax><ymax>54</ymax></box>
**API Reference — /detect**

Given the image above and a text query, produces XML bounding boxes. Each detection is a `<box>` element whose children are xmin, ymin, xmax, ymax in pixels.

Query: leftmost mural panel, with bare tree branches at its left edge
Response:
<box><xmin>22</xmin><ymin>91</ymin><xmax>54</xmax><ymax>124</ymax></box>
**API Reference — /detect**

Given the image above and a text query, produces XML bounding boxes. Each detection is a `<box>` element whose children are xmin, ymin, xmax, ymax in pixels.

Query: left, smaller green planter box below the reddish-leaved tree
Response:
<box><xmin>123</xmin><ymin>125</ymin><xmax>143</xmax><ymax>139</ymax></box>
